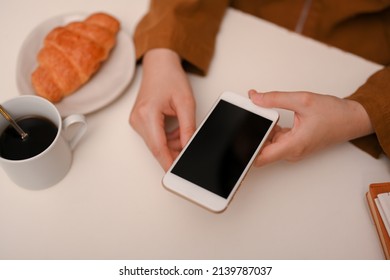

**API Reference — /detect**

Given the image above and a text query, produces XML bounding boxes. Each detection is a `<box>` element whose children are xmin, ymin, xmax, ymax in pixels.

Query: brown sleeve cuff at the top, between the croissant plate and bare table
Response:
<box><xmin>134</xmin><ymin>0</ymin><xmax>229</xmax><ymax>75</ymax></box>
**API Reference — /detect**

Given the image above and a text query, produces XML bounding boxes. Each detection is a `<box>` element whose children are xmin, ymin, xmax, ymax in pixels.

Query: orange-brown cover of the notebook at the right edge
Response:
<box><xmin>366</xmin><ymin>182</ymin><xmax>390</xmax><ymax>260</ymax></box>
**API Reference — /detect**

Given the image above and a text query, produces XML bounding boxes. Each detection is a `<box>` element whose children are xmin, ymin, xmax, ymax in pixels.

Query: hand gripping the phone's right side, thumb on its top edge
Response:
<box><xmin>249</xmin><ymin>90</ymin><xmax>373</xmax><ymax>166</ymax></box>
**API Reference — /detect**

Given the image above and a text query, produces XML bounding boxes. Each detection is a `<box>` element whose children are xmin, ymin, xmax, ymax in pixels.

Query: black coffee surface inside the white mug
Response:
<box><xmin>0</xmin><ymin>116</ymin><xmax>58</xmax><ymax>160</ymax></box>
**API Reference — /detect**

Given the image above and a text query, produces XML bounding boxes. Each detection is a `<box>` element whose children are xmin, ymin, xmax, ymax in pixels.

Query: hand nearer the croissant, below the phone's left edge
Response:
<box><xmin>129</xmin><ymin>49</ymin><xmax>195</xmax><ymax>170</ymax></box>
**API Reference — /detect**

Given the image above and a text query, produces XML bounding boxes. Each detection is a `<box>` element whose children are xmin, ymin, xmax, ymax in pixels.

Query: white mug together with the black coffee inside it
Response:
<box><xmin>0</xmin><ymin>95</ymin><xmax>86</xmax><ymax>190</ymax></box>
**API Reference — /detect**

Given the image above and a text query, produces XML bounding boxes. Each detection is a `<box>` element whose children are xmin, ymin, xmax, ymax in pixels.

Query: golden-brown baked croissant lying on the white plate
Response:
<box><xmin>31</xmin><ymin>13</ymin><xmax>120</xmax><ymax>102</ymax></box>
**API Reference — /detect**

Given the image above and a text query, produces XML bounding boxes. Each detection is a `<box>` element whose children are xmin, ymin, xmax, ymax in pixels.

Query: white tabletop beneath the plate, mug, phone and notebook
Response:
<box><xmin>0</xmin><ymin>0</ymin><xmax>390</xmax><ymax>259</ymax></box>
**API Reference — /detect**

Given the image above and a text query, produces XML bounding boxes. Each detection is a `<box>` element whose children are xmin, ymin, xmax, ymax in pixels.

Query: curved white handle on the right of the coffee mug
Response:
<box><xmin>62</xmin><ymin>114</ymin><xmax>87</xmax><ymax>150</ymax></box>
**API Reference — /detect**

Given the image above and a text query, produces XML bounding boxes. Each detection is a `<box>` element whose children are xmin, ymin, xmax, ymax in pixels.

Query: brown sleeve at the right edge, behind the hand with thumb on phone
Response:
<box><xmin>348</xmin><ymin>67</ymin><xmax>390</xmax><ymax>157</ymax></box>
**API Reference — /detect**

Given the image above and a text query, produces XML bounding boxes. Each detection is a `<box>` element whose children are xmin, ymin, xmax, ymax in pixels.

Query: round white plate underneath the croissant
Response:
<box><xmin>16</xmin><ymin>14</ymin><xmax>135</xmax><ymax>117</ymax></box>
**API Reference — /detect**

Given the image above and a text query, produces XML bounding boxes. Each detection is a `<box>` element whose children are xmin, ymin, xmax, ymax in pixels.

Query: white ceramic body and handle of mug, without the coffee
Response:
<box><xmin>0</xmin><ymin>95</ymin><xmax>86</xmax><ymax>190</ymax></box>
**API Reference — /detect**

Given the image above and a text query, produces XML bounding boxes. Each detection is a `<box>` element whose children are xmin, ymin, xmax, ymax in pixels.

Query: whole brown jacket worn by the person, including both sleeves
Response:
<box><xmin>134</xmin><ymin>0</ymin><xmax>390</xmax><ymax>157</ymax></box>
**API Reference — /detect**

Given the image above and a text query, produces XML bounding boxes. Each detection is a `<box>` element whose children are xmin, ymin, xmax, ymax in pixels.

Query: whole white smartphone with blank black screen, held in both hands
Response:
<box><xmin>162</xmin><ymin>92</ymin><xmax>279</xmax><ymax>212</ymax></box>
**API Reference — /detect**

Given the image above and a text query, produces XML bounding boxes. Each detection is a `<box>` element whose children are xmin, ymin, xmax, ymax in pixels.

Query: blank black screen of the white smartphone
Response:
<box><xmin>171</xmin><ymin>100</ymin><xmax>272</xmax><ymax>198</ymax></box>
